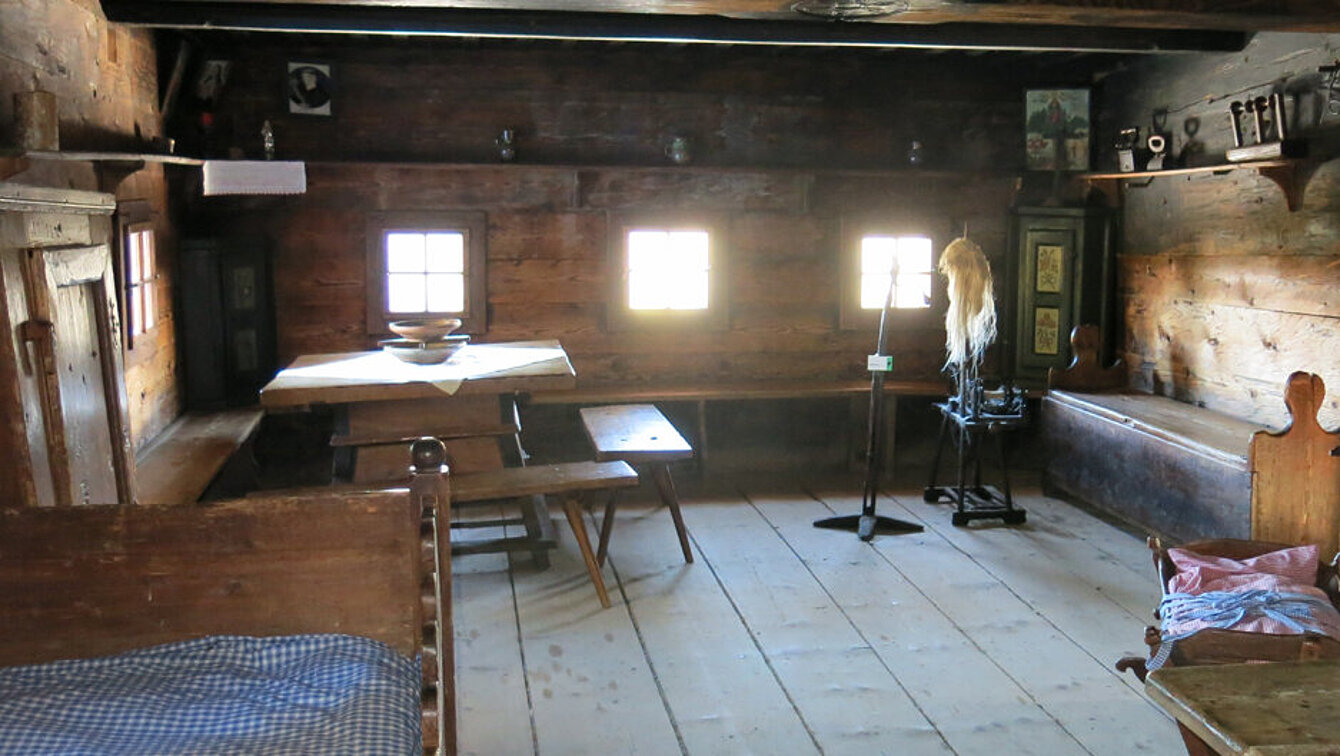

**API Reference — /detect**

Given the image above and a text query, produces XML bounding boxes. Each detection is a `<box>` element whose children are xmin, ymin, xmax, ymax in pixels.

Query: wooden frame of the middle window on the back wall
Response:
<box><xmin>606</xmin><ymin>210</ymin><xmax>730</xmax><ymax>331</ymax></box>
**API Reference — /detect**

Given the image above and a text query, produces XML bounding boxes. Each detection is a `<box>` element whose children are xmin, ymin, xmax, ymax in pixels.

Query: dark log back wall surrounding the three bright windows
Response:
<box><xmin>191</xmin><ymin>36</ymin><xmax>1073</xmax><ymax>394</ymax></box>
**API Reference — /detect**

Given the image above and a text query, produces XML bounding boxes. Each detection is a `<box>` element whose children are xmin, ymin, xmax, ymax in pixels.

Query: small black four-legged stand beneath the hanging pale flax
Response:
<box><xmin>922</xmin><ymin>402</ymin><xmax>1028</xmax><ymax>527</ymax></box>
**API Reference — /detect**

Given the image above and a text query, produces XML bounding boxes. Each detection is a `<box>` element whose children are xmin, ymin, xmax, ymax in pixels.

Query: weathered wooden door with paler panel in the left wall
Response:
<box><xmin>21</xmin><ymin>244</ymin><xmax>134</xmax><ymax>507</ymax></box>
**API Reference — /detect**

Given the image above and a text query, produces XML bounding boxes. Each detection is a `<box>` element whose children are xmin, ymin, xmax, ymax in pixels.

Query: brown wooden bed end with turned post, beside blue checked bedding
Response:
<box><xmin>0</xmin><ymin>440</ymin><xmax>456</xmax><ymax>755</ymax></box>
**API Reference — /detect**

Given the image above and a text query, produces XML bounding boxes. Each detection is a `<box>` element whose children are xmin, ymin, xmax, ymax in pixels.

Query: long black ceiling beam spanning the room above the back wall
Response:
<box><xmin>103</xmin><ymin>0</ymin><xmax>1248</xmax><ymax>54</ymax></box>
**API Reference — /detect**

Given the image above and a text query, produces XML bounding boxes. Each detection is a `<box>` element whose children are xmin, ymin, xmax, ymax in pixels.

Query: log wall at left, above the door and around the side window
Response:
<box><xmin>0</xmin><ymin>0</ymin><xmax>178</xmax><ymax>448</ymax></box>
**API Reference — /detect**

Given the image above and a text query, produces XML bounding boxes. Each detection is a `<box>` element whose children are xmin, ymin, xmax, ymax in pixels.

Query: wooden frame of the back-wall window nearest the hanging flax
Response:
<box><xmin>839</xmin><ymin>214</ymin><xmax>950</xmax><ymax>331</ymax></box>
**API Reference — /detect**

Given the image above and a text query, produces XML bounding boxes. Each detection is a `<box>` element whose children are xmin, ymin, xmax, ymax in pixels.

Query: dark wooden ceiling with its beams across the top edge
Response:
<box><xmin>102</xmin><ymin>0</ymin><xmax>1340</xmax><ymax>52</ymax></box>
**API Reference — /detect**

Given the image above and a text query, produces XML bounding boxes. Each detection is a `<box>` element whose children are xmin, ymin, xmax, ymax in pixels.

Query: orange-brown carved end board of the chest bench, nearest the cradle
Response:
<box><xmin>1248</xmin><ymin>371</ymin><xmax>1340</xmax><ymax>559</ymax></box>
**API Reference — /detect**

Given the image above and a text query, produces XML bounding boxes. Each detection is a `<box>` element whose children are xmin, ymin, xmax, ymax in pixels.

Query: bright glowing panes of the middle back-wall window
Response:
<box><xmin>627</xmin><ymin>228</ymin><xmax>712</xmax><ymax>310</ymax></box>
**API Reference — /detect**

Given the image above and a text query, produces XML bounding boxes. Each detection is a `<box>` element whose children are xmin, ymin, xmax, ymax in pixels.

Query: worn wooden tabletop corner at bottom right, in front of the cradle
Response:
<box><xmin>1144</xmin><ymin>659</ymin><xmax>1340</xmax><ymax>756</ymax></box>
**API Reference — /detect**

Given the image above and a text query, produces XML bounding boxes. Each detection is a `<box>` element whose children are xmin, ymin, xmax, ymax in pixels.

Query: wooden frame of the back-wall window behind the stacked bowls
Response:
<box><xmin>367</xmin><ymin>210</ymin><xmax>488</xmax><ymax>338</ymax></box>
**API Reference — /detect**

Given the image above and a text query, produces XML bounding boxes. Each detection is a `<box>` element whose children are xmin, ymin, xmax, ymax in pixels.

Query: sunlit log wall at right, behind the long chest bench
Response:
<box><xmin>1097</xmin><ymin>34</ymin><xmax>1340</xmax><ymax>428</ymax></box>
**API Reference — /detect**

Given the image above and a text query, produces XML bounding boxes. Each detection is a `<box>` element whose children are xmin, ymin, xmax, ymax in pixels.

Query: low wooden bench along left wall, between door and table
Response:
<box><xmin>135</xmin><ymin>407</ymin><xmax>265</xmax><ymax>507</ymax></box>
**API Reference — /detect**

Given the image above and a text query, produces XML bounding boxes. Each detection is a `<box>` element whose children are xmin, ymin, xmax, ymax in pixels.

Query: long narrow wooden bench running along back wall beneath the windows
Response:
<box><xmin>523</xmin><ymin>378</ymin><xmax>950</xmax><ymax>469</ymax></box>
